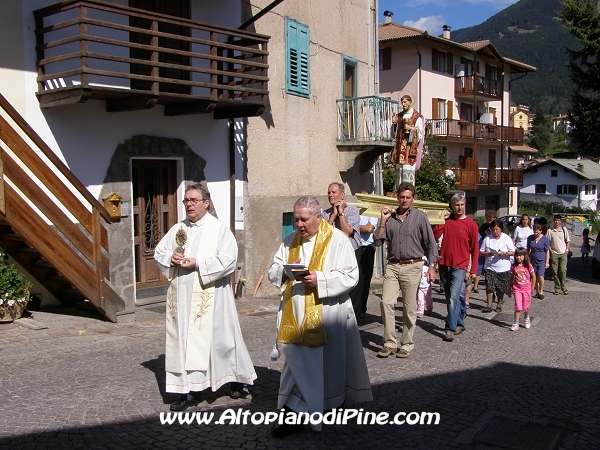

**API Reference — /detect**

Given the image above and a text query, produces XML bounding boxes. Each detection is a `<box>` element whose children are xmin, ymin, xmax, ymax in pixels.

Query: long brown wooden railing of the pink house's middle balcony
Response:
<box><xmin>427</xmin><ymin>119</ymin><xmax>524</xmax><ymax>145</ymax></box>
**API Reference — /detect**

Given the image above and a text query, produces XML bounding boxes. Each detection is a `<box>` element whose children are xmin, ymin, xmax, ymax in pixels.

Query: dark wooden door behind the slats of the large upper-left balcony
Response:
<box><xmin>129</xmin><ymin>0</ymin><xmax>190</xmax><ymax>94</ymax></box>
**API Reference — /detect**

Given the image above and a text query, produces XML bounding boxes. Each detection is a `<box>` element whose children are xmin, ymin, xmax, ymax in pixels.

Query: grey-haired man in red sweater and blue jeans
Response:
<box><xmin>433</xmin><ymin>193</ymin><xmax>479</xmax><ymax>341</ymax></box>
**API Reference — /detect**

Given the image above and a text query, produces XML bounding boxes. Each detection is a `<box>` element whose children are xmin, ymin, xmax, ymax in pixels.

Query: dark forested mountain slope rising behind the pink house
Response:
<box><xmin>452</xmin><ymin>0</ymin><xmax>578</xmax><ymax>115</ymax></box>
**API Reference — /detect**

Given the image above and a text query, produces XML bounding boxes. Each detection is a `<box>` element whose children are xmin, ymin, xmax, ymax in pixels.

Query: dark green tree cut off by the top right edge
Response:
<box><xmin>560</xmin><ymin>0</ymin><xmax>600</xmax><ymax>155</ymax></box>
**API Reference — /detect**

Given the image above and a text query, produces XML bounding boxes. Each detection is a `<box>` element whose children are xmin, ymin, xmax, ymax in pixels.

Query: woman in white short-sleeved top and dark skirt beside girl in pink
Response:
<box><xmin>479</xmin><ymin>219</ymin><xmax>516</xmax><ymax>313</ymax></box>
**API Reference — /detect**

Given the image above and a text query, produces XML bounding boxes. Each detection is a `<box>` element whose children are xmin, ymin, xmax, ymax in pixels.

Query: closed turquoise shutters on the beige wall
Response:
<box><xmin>285</xmin><ymin>18</ymin><xmax>310</xmax><ymax>98</ymax></box>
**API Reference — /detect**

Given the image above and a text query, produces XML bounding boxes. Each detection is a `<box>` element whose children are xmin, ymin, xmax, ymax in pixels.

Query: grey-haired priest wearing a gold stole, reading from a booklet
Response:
<box><xmin>269</xmin><ymin>197</ymin><xmax>373</xmax><ymax>437</ymax></box>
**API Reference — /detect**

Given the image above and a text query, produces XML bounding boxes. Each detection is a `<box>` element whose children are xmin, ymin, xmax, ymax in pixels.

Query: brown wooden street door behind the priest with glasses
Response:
<box><xmin>131</xmin><ymin>159</ymin><xmax>177</xmax><ymax>290</ymax></box>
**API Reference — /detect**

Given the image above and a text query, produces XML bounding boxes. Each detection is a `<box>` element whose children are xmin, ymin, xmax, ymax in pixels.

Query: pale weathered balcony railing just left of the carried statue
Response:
<box><xmin>337</xmin><ymin>96</ymin><xmax>398</xmax><ymax>146</ymax></box>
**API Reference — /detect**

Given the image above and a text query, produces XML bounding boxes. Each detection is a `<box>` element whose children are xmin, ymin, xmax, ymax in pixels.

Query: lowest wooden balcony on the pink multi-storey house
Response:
<box><xmin>452</xmin><ymin>156</ymin><xmax>523</xmax><ymax>191</ymax></box>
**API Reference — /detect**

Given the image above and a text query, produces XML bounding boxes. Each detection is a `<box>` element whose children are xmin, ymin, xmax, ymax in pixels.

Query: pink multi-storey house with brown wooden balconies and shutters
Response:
<box><xmin>379</xmin><ymin>20</ymin><xmax>537</xmax><ymax>215</ymax></box>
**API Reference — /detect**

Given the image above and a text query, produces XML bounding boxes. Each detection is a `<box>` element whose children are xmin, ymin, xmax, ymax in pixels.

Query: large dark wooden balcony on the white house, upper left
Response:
<box><xmin>34</xmin><ymin>0</ymin><xmax>269</xmax><ymax>119</ymax></box>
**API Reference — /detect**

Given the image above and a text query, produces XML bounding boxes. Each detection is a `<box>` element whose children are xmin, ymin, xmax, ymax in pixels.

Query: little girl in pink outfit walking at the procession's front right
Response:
<box><xmin>508</xmin><ymin>248</ymin><xmax>535</xmax><ymax>331</ymax></box>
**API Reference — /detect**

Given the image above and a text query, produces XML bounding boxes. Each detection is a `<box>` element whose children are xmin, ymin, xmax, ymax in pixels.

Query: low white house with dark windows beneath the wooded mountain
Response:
<box><xmin>519</xmin><ymin>159</ymin><xmax>600</xmax><ymax>211</ymax></box>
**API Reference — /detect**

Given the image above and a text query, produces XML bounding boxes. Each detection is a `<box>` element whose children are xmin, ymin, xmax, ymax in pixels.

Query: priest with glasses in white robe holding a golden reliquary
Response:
<box><xmin>154</xmin><ymin>184</ymin><xmax>256</xmax><ymax>411</ymax></box>
